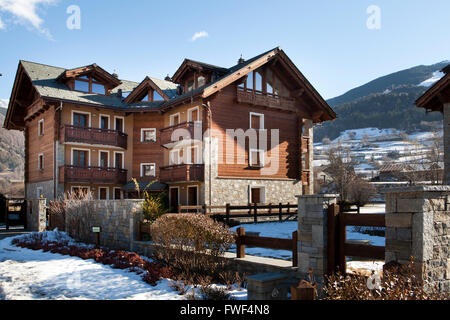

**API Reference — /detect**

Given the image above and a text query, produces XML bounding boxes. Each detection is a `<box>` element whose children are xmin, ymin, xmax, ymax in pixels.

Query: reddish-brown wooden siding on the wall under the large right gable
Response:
<box><xmin>211</xmin><ymin>85</ymin><xmax>300</xmax><ymax>179</ymax></box>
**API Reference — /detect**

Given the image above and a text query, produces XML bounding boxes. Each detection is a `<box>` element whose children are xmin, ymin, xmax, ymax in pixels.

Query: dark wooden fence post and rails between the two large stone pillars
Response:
<box><xmin>328</xmin><ymin>204</ymin><xmax>386</xmax><ymax>273</ymax></box>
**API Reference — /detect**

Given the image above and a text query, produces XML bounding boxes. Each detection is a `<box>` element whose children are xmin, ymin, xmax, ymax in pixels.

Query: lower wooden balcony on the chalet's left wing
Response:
<box><xmin>59</xmin><ymin>165</ymin><xmax>127</xmax><ymax>184</ymax></box>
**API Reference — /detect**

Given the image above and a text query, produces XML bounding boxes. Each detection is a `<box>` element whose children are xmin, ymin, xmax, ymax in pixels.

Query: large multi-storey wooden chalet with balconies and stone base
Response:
<box><xmin>4</xmin><ymin>48</ymin><xmax>336</xmax><ymax>207</ymax></box>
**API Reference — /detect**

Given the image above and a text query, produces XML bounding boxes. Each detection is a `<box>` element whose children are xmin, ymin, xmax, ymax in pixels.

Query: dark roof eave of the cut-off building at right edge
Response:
<box><xmin>416</xmin><ymin>64</ymin><xmax>450</xmax><ymax>112</ymax></box>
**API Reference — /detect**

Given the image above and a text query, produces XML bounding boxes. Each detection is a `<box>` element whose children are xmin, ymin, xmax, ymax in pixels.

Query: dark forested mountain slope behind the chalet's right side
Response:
<box><xmin>314</xmin><ymin>62</ymin><xmax>450</xmax><ymax>142</ymax></box>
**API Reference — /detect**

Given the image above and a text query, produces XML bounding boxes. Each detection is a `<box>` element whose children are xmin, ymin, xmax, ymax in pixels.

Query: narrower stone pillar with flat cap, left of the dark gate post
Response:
<box><xmin>297</xmin><ymin>194</ymin><xmax>338</xmax><ymax>285</ymax></box>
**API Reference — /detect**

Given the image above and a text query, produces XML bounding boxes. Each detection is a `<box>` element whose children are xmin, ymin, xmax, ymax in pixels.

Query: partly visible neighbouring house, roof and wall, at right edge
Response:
<box><xmin>416</xmin><ymin>65</ymin><xmax>450</xmax><ymax>184</ymax></box>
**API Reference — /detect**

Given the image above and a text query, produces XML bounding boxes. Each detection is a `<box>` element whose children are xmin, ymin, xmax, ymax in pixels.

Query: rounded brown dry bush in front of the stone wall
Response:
<box><xmin>151</xmin><ymin>214</ymin><xmax>234</xmax><ymax>283</ymax></box>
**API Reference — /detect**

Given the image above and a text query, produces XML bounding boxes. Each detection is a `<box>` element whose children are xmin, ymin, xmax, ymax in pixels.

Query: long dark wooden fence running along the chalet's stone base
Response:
<box><xmin>178</xmin><ymin>202</ymin><xmax>298</xmax><ymax>224</ymax></box>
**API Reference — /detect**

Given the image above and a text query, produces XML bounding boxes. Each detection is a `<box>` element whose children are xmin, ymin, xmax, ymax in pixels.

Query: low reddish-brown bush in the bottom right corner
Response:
<box><xmin>324</xmin><ymin>263</ymin><xmax>450</xmax><ymax>300</ymax></box>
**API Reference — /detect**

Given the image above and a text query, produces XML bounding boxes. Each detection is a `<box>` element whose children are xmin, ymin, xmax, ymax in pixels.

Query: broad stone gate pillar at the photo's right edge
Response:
<box><xmin>385</xmin><ymin>186</ymin><xmax>450</xmax><ymax>291</ymax></box>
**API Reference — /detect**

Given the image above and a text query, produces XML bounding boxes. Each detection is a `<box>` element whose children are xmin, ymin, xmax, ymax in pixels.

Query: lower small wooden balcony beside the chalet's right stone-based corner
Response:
<box><xmin>160</xmin><ymin>164</ymin><xmax>205</xmax><ymax>183</ymax></box>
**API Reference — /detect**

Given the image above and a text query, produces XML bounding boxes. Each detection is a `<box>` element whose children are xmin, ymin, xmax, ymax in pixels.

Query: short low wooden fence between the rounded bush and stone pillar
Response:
<box><xmin>236</xmin><ymin>228</ymin><xmax>298</xmax><ymax>267</ymax></box>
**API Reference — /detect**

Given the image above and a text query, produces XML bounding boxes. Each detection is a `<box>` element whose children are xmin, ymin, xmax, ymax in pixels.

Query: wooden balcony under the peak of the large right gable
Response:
<box><xmin>237</xmin><ymin>87</ymin><xmax>297</xmax><ymax>112</ymax></box>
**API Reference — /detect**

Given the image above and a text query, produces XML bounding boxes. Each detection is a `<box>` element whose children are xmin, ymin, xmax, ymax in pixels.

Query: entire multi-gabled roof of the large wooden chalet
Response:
<box><xmin>7</xmin><ymin>47</ymin><xmax>336</xmax><ymax>129</ymax></box>
